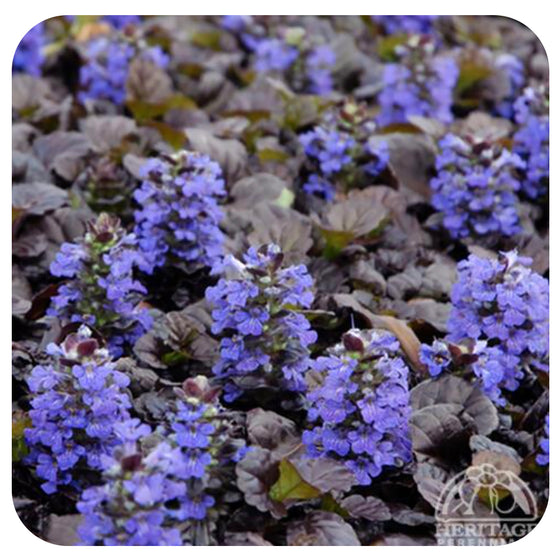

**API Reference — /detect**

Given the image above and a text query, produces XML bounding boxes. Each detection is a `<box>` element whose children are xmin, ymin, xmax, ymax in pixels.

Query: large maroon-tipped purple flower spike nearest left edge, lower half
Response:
<box><xmin>25</xmin><ymin>326</ymin><xmax>131</xmax><ymax>494</ymax></box>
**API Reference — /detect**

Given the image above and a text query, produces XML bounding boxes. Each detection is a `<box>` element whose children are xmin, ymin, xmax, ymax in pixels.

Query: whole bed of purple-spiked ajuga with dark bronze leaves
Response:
<box><xmin>12</xmin><ymin>16</ymin><xmax>549</xmax><ymax>546</ymax></box>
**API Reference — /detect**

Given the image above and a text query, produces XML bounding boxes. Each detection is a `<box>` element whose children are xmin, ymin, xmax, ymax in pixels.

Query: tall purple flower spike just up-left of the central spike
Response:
<box><xmin>134</xmin><ymin>151</ymin><xmax>226</xmax><ymax>274</ymax></box>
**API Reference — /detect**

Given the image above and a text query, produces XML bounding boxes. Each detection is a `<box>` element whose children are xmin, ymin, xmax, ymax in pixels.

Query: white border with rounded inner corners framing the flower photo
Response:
<box><xmin>0</xmin><ymin>0</ymin><xmax>560</xmax><ymax>560</ymax></box>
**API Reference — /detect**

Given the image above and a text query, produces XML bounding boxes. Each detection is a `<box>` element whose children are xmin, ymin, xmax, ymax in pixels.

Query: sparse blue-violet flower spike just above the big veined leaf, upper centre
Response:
<box><xmin>299</xmin><ymin>101</ymin><xmax>389</xmax><ymax>200</ymax></box>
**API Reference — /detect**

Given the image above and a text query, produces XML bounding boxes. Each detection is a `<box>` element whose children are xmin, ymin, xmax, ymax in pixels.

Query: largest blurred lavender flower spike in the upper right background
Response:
<box><xmin>378</xmin><ymin>34</ymin><xmax>459</xmax><ymax>126</ymax></box>
